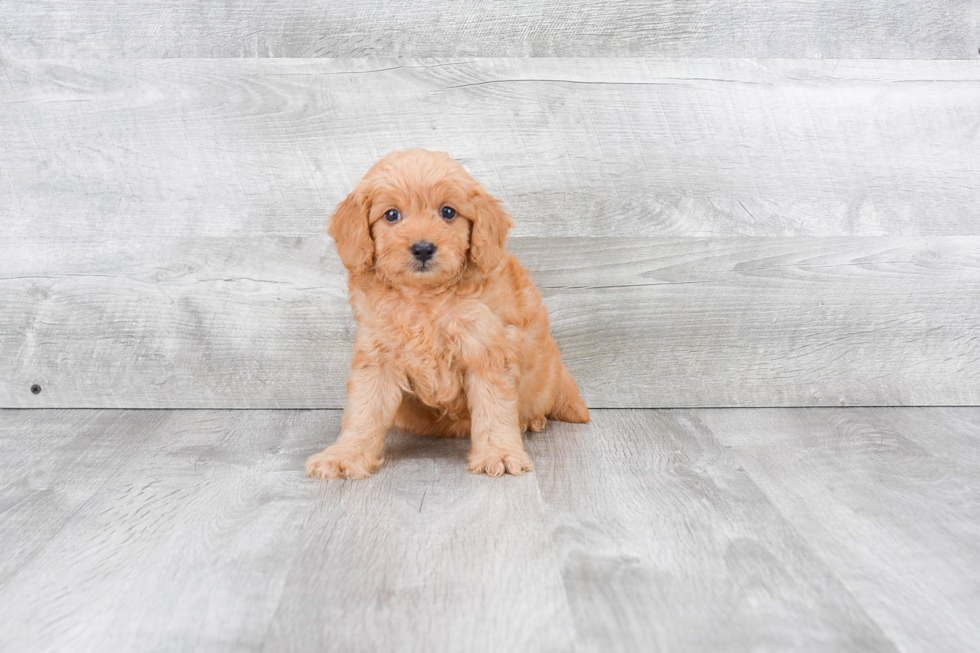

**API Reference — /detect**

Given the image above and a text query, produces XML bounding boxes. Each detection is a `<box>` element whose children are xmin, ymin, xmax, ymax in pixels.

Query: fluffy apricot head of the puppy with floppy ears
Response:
<box><xmin>328</xmin><ymin>148</ymin><xmax>513</xmax><ymax>288</ymax></box>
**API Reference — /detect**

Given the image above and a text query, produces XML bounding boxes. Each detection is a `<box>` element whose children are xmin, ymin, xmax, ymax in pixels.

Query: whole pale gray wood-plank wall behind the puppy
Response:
<box><xmin>0</xmin><ymin>0</ymin><xmax>980</xmax><ymax>408</ymax></box>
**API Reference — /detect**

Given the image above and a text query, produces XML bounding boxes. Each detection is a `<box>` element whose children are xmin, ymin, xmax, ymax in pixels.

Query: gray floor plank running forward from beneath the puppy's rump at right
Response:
<box><xmin>528</xmin><ymin>411</ymin><xmax>896</xmax><ymax>651</ymax></box>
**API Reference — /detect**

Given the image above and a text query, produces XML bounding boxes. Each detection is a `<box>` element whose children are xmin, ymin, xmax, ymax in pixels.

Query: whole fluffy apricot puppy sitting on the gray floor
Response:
<box><xmin>306</xmin><ymin>149</ymin><xmax>589</xmax><ymax>479</ymax></box>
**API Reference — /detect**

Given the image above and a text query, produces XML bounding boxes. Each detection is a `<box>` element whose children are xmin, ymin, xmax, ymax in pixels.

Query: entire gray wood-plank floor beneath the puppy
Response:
<box><xmin>0</xmin><ymin>408</ymin><xmax>980</xmax><ymax>652</ymax></box>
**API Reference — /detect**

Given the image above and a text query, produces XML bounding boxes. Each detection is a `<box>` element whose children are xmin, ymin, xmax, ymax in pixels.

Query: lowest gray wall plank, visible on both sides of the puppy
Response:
<box><xmin>0</xmin><ymin>236</ymin><xmax>980</xmax><ymax>408</ymax></box>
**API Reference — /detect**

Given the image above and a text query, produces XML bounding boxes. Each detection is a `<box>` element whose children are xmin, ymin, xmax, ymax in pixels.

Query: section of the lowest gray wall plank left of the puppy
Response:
<box><xmin>0</xmin><ymin>235</ymin><xmax>354</xmax><ymax>408</ymax></box>
